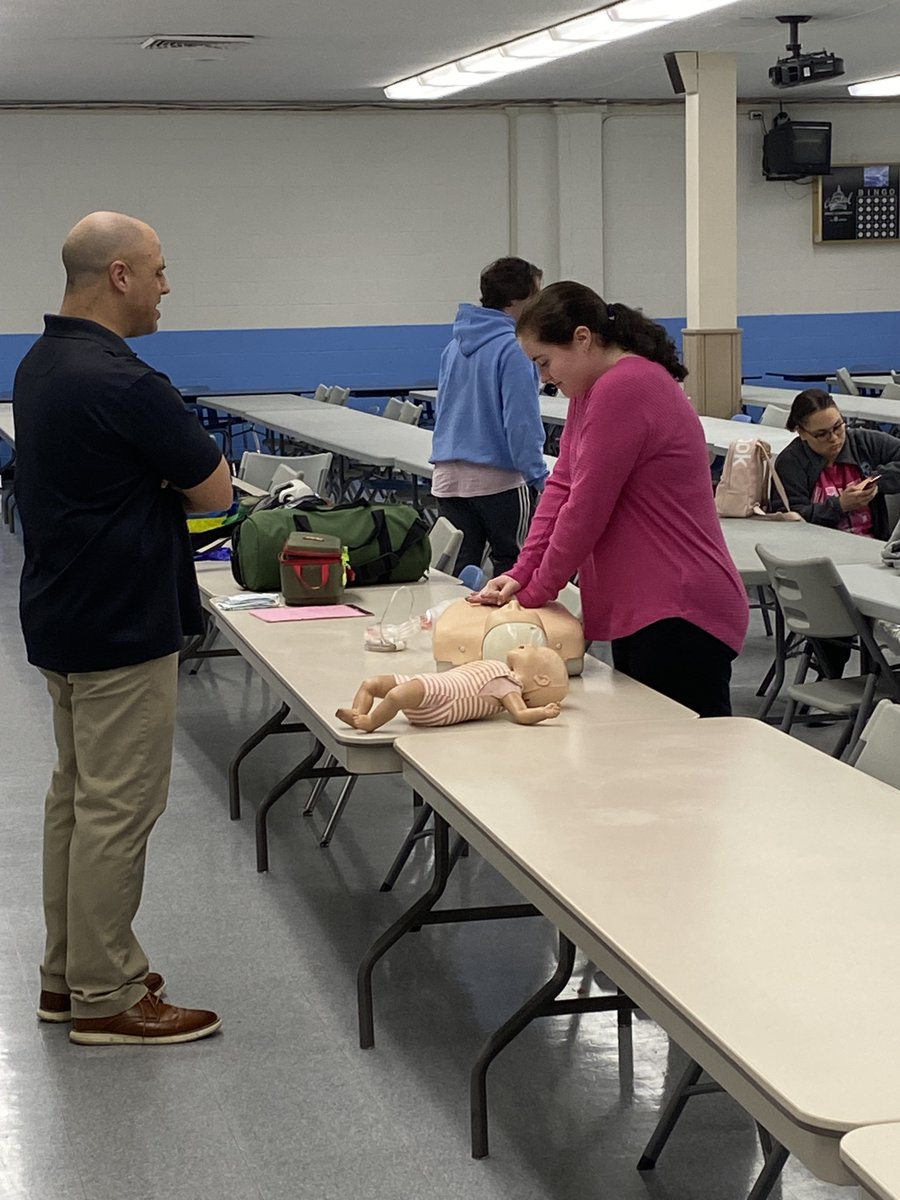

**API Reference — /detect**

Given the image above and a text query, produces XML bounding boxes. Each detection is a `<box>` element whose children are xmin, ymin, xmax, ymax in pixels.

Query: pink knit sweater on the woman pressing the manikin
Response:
<box><xmin>509</xmin><ymin>356</ymin><xmax>749</xmax><ymax>653</ymax></box>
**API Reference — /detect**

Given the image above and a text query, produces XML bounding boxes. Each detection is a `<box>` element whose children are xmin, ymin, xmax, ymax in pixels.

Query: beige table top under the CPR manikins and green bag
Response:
<box><xmin>197</xmin><ymin>563</ymin><xmax>696</xmax><ymax>774</ymax></box>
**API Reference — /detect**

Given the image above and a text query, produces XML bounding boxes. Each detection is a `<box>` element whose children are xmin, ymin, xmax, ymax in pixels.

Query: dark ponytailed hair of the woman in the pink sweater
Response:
<box><xmin>516</xmin><ymin>280</ymin><xmax>688</xmax><ymax>383</ymax></box>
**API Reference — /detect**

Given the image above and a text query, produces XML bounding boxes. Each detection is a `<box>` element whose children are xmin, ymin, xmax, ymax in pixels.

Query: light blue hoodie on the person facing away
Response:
<box><xmin>431</xmin><ymin>304</ymin><xmax>547</xmax><ymax>488</ymax></box>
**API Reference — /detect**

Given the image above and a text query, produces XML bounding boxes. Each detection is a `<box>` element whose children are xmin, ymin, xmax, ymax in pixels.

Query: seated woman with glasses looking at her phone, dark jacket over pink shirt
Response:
<box><xmin>772</xmin><ymin>388</ymin><xmax>900</xmax><ymax>541</ymax></box>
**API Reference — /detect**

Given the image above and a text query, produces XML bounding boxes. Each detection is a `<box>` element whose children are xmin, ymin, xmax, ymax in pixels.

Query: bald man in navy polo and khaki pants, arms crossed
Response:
<box><xmin>13</xmin><ymin>212</ymin><xmax>232</xmax><ymax>1045</ymax></box>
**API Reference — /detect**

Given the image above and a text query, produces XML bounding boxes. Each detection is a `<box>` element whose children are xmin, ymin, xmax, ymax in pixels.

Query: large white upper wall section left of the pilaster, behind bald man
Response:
<box><xmin>0</xmin><ymin>112</ymin><xmax>509</xmax><ymax>334</ymax></box>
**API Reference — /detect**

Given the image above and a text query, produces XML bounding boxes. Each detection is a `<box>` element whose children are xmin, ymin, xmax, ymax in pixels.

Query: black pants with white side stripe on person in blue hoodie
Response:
<box><xmin>438</xmin><ymin>484</ymin><xmax>536</xmax><ymax>575</ymax></box>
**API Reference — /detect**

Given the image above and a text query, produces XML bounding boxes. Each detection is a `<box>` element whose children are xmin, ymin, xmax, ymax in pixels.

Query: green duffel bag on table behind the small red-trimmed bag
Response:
<box><xmin>232</xmin><ymin>499</ymin><xmax>431</xmax><ymax>592</ymax></box>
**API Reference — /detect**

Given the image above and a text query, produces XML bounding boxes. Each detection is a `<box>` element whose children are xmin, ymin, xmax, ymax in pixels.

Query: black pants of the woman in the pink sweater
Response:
<box><xmin>612</xmin><ymin>617</ymin><xmax>737</xmax><ymax>716</ymax></box>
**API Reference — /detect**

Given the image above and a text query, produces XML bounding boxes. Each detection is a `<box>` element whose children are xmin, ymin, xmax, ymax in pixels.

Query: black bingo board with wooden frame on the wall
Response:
<box><xmin>814</xmin><ymin>162</ymin><xmax>900</xmax><ymax>245</ymax></box>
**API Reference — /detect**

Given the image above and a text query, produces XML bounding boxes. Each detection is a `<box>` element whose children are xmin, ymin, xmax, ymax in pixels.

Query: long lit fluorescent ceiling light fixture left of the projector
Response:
<box><xmin>384</xmin><ymin>0</ymin><xmax>748</xmax><ymax>101</ymax></box>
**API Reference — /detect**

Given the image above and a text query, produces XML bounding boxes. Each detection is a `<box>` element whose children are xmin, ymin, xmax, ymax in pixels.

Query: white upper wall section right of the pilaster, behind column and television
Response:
<box><xmin>602</xmin><ymin>103</ymin><xmax>900</xmax><ymax>317</ymax></box>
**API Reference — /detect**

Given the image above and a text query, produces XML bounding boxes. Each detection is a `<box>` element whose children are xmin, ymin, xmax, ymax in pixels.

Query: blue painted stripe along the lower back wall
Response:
<box><xmin>0</xmin><ymin>312</ymin><xmax>900</xmax><ymax>392</ymax></box>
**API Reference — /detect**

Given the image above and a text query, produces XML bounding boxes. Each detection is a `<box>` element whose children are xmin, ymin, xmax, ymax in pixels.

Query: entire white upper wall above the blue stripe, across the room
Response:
<box><xmin>0</xmin><ymin>104</ymin><xmax>900</xmax><ymax>334</ymax></box>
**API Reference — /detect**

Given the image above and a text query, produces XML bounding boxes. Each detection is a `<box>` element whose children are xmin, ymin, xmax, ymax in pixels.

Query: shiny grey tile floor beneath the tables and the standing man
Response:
<box><xmin>0</xmin><ymin>529</ymin><xmax>854</xmax><ymax>1200</ymax></box>
